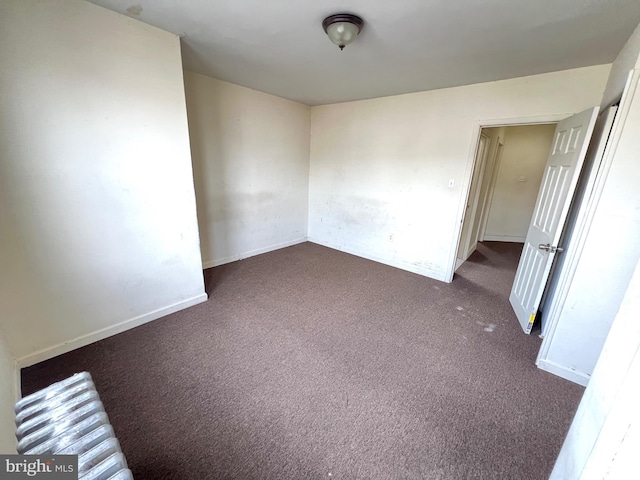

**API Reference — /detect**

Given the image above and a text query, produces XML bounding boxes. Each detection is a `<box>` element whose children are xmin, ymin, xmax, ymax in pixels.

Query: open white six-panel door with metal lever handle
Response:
<box><xmin>509</xmin><ymin>107</ymin><xmax>598</xmax><ymax>333</ymax></box>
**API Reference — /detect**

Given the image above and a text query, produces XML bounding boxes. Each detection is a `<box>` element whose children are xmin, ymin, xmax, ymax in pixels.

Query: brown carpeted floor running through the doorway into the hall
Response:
<box><xmin>22</xmin><ymin>242</ymin><xmax>583</xmax><ymax>480</ymax></box>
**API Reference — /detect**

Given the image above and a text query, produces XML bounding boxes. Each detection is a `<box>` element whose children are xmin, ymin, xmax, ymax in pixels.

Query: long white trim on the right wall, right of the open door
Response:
<box><xmin>536</xmin><ymin>70</ymin><xmax>640</xmax><ymax>366</ymax></box>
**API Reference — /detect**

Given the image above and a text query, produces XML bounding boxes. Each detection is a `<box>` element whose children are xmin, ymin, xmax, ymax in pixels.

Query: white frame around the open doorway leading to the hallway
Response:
<box><xmin>445</xmin><ymin>113</ymin><xmax>574</xmax><ymax>283</ymax></box>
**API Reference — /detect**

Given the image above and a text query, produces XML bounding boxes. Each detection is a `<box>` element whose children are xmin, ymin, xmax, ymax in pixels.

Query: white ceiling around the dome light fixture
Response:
<box><xmin>91</xmin><ymin>0</ymin><xmax>640</xmax><ymax>105</ymax></box>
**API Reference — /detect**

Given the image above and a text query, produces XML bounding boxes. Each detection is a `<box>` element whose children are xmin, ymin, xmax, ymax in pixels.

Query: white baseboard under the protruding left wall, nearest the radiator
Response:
<box><xmin>17</xmin><ymin>293</ymin><xmax>208</xmax><ymax>368</ymax></box>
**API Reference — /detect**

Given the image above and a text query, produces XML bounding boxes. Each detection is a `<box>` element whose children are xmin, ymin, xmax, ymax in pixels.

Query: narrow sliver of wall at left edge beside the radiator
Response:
<box><xmin>0</xmin><ymin>331</ymin><xmax>17</xmax><ymax>453</ymax></box>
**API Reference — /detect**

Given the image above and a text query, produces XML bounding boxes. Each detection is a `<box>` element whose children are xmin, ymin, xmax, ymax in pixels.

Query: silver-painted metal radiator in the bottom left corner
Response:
<box><xmin>15</xmin><ymin>372</ymin><xmax>133</xmax><ymax>480</ymax></box>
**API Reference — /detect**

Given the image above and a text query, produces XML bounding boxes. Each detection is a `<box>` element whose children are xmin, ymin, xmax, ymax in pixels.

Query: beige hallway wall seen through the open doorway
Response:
<box><xmin>484</xmin><ymin>124</ymin><xmax>556</xmax><ymax>242</ymax></box>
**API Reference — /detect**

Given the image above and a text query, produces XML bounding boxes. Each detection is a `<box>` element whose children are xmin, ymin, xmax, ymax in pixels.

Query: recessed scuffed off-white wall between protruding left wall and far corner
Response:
<box><xmin>185</xmin><ymin>71</ymin><xmax>310</xmax><ymax>267</ymax></box>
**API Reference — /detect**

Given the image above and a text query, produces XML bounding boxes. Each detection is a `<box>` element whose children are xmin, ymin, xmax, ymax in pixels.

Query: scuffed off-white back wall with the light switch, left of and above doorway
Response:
<box><xmin>309</xmin><ymin>65</ymin><xmax>610</xmax><ymax>280</ymax></box>
